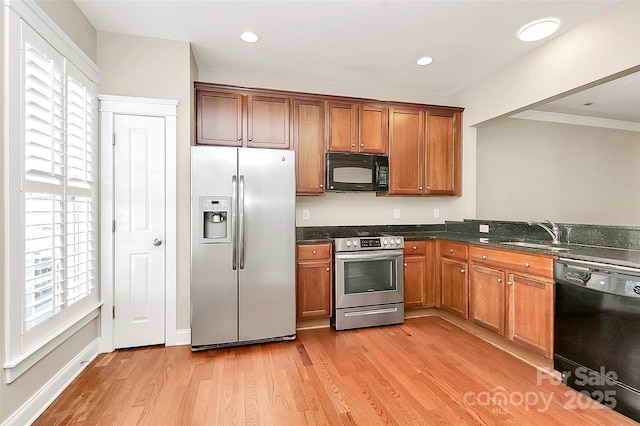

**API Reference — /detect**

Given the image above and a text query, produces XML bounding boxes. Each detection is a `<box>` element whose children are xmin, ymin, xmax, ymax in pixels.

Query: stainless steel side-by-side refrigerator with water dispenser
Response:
<box><xmin>191</xmin><ymin>146</ymin><xmax>296</xmax><ymax>350</ymax></box>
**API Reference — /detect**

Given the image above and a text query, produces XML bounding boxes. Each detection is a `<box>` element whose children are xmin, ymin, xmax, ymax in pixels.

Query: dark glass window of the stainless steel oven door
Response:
<box><xmin>344</xmin><ymin>259</ymin><xmax>397</xmax><ymax>294</ymax></box>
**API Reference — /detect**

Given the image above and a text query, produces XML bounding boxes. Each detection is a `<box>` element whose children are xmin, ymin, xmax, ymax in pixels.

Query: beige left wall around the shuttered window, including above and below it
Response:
<box><xmin>0</xmin><ymin>0</ymin><xmax>99</xmax><ymax>423</ymax></box>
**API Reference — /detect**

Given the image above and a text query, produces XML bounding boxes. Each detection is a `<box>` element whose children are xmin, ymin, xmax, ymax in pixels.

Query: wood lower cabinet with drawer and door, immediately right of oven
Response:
<box><xmin>404</xmin><ymin>241</ymin><xmax>436</xmax><ymax>309</ymax></box>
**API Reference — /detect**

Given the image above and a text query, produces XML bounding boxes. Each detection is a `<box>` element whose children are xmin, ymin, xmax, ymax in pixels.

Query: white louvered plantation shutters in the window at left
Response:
<box><xmin>21</xmin><ymin>24</ymin><xmax>98</xmax><ymax>342</ymax></box>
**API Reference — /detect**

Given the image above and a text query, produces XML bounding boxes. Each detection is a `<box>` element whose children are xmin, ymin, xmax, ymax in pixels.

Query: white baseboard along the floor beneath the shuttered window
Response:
<box><xmin>2</xmin><ymin>339</ymin><xmax>100</xmax><ymax>426</ymax></box>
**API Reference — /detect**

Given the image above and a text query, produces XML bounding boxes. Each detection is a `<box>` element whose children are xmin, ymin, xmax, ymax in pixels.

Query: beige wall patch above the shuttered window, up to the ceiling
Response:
<box><xmin>36</xmin><ymin>0</ymin><xmax>98</xmax><ymax>62</ymax></box>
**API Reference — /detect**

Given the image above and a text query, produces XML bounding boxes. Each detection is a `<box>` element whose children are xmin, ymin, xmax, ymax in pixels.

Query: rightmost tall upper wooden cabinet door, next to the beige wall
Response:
<box><xmin>425</xmin><ymin>111</ymin><xmax>462</xmax><ymax>195</ymax></box>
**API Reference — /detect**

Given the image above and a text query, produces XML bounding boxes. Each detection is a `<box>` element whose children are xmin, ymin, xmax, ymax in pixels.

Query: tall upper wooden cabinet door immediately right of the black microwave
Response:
<box><xmin>389</xmin><ymin>108</ymin><xmax>424</xmax><ymax>195</ymax></box>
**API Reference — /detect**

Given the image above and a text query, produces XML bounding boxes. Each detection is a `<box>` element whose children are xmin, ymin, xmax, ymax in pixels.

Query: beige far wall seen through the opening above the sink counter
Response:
<box><xmin>477</xmin><ymin>118</ymin><xmax>640</xmax><ymax>226</ymax></box>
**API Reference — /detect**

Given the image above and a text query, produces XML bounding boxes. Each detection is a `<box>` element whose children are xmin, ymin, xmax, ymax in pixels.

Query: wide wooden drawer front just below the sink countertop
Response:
<box><xmin>469</xmin><ymin>246</ymin><xmax>553</xmax><ymax>278</ymax></box>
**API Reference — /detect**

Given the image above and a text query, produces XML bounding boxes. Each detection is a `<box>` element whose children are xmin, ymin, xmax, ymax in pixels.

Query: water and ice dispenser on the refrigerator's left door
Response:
<box><xmin>200</xmin><ymin>197</ymin><xmax>231</xmax><ymax>243</ymax></box>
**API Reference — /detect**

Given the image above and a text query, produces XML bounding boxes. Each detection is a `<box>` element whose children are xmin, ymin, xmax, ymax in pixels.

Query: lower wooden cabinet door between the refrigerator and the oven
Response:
<box><xmin>296</xmin><ymin>261</ymin><xmax>333</xmax><ymax>318</ymax></box>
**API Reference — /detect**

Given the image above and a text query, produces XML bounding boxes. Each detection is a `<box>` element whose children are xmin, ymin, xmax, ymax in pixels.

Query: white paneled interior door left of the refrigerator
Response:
<box><xmin>113</xmin><ymin>115</ymin><xmax>165</xmax><ymax>348</ymax></box>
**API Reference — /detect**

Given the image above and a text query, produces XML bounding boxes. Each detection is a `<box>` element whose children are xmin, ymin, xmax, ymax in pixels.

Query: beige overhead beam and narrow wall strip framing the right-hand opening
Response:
<box><xmin>453</xmin><ymin>1</ymin><xmax>640</xmax><ymax>223</ymax></box>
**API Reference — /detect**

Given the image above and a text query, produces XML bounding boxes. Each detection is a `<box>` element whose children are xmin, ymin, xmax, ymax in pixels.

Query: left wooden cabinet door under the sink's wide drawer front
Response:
<box><xmin>469</xmin><ymin>265</ymin><xmax>506</xmax><ymax>336</ymax></box>
